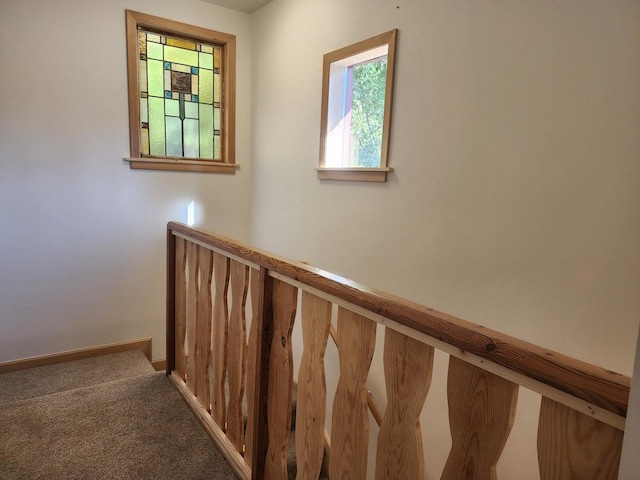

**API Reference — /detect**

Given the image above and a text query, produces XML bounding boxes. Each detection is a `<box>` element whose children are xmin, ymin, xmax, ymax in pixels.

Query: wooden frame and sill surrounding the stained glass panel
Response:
<box><xmin>124</xmin><ymin>10</ymin><xmax>240</xmax><ymax>174</ymax></box>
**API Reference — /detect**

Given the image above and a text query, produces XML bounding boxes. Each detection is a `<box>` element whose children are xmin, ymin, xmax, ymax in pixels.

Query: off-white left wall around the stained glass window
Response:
<box><xmin>0</xmin><ymin>0</ymin><xmax>251</xmax><ymax>361</ymax></box>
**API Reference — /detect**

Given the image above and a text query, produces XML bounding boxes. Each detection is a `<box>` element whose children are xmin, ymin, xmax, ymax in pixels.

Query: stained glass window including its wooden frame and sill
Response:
<box><xmin>127</xmin><ymin>10</ymin><xmax>237</xmax><ymax>173</ymax></box>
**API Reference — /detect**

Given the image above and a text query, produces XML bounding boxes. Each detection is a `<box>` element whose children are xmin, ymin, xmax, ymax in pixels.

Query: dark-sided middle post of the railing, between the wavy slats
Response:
<box><xmin>245</xmin><ymin>268</ymin><xmax>273</xmax><ymax>480</ymax></box>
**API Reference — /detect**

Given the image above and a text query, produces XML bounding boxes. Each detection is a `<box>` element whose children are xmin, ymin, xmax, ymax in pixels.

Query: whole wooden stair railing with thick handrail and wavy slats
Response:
<box><xmin>167</xmin><ymin>222</ymin><xmax>630</xmax><ymax>480</ymax></box>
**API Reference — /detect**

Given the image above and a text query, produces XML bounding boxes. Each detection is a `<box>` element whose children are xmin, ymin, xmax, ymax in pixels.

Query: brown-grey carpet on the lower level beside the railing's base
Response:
<box><xmin>0</xmin><ymin>354</ymin><xmax>237</xmax><ymax>480</ymax></box>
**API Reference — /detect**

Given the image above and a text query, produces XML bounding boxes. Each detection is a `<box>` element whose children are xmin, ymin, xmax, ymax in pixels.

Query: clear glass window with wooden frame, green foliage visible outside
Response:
<box><xmin>318</xmin><ymin>30</ymin><xmax>396</xmax><ymax>182</ymax></box>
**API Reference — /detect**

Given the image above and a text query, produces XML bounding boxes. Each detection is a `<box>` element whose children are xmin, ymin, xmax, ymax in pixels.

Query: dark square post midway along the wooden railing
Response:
<box><xmin>248</xmin><ymin>267</ymin><xmax>273</xmax><ymax>480</ymax></box>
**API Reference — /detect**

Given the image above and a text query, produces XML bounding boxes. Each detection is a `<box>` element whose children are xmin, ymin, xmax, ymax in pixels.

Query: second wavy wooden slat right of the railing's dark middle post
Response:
<box><xmin>296</xmin><ymin>292</ymin><xmax>331</xmax><ymax>480</ymax></box>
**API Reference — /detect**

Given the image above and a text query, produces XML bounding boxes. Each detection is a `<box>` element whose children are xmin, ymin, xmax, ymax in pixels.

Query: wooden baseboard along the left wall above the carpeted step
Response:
<box><xmin>0</xmin><ymin>338</ymin><xmax>151</xmax><ymax>373</ymax></box>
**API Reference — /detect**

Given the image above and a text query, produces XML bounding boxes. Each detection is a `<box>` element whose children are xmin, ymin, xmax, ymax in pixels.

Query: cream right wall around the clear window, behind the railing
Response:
<box><xmin>251</xmin><ymin>0</ymin><xmax>640</xmax><ymax>479</ymax></box>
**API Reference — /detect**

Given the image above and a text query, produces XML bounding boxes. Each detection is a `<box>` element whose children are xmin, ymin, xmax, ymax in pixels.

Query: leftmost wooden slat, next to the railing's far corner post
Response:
<box><xmin>174</xmin><ymin>237</ymin><xmax>187</xmax><ymax>380</ymax></box>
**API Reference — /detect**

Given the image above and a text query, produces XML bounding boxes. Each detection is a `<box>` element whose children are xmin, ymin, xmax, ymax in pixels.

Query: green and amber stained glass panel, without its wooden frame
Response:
<box><xmin>138</xmin><ymin>28</ymin><xmax>222</xmax><ymax>160</ymax></box>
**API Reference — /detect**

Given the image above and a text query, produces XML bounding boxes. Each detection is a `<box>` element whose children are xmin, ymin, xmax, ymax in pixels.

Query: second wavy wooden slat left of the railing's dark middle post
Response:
<box><xmin>227</xmin><ymin>260</ymin><xmax>249</xmax><ymax>453</ymax></box>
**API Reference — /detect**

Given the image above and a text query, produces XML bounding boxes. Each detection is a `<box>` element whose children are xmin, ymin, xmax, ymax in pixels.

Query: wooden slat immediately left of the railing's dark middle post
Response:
<box><xmin>244</xmin><ymin>268</ymin><xmax>262</xmax><ymax>465</ymax></box>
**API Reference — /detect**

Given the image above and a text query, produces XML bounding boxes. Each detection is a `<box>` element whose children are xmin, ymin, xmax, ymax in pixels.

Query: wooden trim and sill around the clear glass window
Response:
<box><xmin>316</xmin><ymin>29</ymin><xmax>398</xmax><ymax>182</ymax></box>
